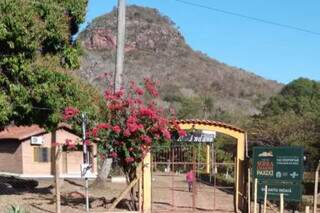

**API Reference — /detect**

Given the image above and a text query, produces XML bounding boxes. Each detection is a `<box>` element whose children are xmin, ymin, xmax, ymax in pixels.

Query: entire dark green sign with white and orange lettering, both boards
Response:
<box><xmin>253</xmin><ymin>146</ymin><xmax>303</xmax><ymax>201</ymax></box>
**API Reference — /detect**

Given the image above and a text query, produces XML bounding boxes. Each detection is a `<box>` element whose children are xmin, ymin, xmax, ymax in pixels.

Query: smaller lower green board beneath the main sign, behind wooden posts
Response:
<box><xmin>257</xmin><ymin>181</ymin><xmax>302</xmax><ymax>202</ymax></box>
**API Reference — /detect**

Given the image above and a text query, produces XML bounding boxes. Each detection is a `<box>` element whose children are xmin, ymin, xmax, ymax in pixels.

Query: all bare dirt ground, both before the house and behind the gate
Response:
<box><xmin>0</xmin><ymin>173</ymin><xmax>233</xmax><ymax>213</ymax></box>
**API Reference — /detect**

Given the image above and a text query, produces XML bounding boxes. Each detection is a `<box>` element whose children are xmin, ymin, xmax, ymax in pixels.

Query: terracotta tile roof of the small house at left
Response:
<box><xmin>0</xmin><ymin>124</ymin><xmax>71</xmax><ymax>140</ymax></box>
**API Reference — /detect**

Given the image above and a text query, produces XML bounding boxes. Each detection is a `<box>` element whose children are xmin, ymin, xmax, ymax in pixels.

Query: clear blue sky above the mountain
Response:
<box><xmin>81</xmin><ymin>0</ymin><xmax>320</xmax><ymax>83</ymax></box>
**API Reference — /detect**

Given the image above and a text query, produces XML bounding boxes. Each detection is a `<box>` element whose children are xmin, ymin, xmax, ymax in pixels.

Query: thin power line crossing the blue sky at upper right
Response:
<box><xmin>175</xmin><ymin>0</ymin><xmax>320</xmax><ymax>36</ymax></box>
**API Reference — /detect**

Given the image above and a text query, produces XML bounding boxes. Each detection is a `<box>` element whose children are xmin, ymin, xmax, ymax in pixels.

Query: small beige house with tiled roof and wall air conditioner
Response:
<box><xmin>0</xmin><ymin>124</ymin><xmax>97</xmax><ymax>178</ymax></box>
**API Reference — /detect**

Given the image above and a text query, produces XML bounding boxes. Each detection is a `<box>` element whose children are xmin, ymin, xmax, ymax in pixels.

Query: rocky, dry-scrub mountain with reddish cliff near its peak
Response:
<box><xmin>78</xmin><ymin>6</ymin><xmax>282</xmax><ymax>118</ymax></box>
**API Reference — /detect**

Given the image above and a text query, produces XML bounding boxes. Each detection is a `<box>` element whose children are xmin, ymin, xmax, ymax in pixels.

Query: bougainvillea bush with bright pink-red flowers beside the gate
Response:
<box><xmin>65</xmin><ymin>78</ymin><xmax>185</xmax><ymax>182</ymax></box>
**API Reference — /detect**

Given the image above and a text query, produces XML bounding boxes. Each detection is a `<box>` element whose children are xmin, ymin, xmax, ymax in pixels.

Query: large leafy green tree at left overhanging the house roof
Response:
<box><xmin>0</xmin><ymin>0</ymin><xmax>100</xmax><ymax>128</ymax></box>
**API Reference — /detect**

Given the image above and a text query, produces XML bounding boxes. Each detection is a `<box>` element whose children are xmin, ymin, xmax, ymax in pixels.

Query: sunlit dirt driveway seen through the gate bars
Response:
<box><xmin>152</xmin><ymin>173</ymin><xmax>233</xmax><ymax>213</ymax></box>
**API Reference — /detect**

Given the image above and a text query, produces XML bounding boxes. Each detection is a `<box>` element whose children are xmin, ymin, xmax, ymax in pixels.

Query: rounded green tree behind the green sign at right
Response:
<box><xmin>250</xmin><ymin>78</ymin><xmax>320</xmax><ymax>168</ymax></box>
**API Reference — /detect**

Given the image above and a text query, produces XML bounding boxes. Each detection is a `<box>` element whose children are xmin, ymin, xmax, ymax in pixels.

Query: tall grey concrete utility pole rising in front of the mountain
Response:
<box><xmin>114</xmin><ymin>0</ymin><xmax>126</xmax><ymax>91</ymax></box>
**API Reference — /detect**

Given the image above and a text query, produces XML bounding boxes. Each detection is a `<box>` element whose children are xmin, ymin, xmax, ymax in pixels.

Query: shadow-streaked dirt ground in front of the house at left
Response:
<box><xmin>0</xmin><ymin>179</ymin><xmax>126</xmax><ymax>213</ymax></box>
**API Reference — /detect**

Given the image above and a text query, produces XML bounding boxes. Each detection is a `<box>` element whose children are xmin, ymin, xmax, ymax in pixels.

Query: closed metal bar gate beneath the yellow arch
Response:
<box><xmin>152</xmin><ymin>143</ymin><xmax>234</xmax><ymax>212</ymax></box>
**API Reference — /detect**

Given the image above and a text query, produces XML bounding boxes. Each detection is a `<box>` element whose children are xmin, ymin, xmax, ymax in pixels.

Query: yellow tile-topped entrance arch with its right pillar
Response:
<box><xmin>176</xmin><ymin>119</ymin><xmax>247</xmax><ymax>212</ymax></box>
